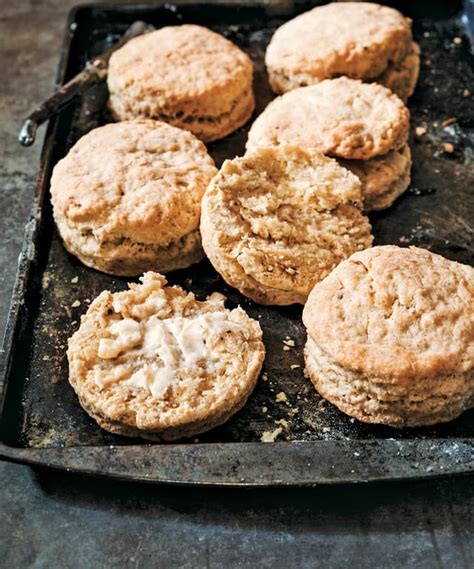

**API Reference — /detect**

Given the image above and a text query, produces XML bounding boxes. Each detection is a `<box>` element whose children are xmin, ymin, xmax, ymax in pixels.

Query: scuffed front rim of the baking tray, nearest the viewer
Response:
<box><xmin>0</xmin><ymin>439</ymin><xmax>474</xmax><ymax>486</ymax></box>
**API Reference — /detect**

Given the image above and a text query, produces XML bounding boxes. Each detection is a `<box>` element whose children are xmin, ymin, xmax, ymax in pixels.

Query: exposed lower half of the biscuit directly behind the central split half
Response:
<box><xmin>338</xmin><ymin>144</ymin><xmax>411</xmax><ymax>211</ymax></box>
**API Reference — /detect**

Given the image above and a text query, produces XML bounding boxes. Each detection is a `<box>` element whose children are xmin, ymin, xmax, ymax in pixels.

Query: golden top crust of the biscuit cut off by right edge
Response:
<box><xmin>303</xmin><ymin>245</ymin><xmax>474</xmax><ymax>381</ymax></box>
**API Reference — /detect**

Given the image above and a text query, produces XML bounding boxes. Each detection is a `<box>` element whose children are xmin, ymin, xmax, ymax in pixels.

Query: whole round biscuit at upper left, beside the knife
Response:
<box><xmin>107</xmin><ymin>24</ymin><xmax>255</xmax><ymax>142</ymax></box>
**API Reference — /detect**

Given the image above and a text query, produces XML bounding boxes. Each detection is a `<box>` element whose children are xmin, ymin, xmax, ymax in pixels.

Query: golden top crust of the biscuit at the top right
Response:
<box><xmin>265</xmin><ymin>2</ymin><xmax>412</xmax><ymax>86</ymax></box>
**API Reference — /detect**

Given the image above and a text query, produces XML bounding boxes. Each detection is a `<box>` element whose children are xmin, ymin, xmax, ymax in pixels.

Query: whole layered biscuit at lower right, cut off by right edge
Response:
<box><xmin>303</xmin><ymin>245</ymin><xmax>474</xmax><ymax>427</ymax></box>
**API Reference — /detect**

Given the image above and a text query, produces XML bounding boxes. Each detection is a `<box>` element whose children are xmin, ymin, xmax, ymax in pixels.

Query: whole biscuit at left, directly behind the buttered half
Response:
<box><xmin>51</xmin><ymin>120</ymin><xmax>217</xmax><ymax>276</ymax></box>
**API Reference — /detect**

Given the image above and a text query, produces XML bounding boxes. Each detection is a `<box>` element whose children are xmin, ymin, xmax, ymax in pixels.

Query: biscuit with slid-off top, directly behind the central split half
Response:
<box><xmin>247</xmin><ymin>79</ymin><xmax>411</xmax><ymax>207</ymax></box>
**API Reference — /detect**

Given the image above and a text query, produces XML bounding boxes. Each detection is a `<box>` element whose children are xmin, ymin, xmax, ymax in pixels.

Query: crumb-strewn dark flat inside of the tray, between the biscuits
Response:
<box><xmin>1</xmin><ymin>6</ymin><xmax>474</xmax><ymax>474</ymax></box>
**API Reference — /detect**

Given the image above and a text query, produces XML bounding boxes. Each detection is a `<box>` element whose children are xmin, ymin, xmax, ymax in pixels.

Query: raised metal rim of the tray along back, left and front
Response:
<box><xmin>0</xmin><ymin>0</ymin><xmax>474</xmax><ymax>487</ymax></box>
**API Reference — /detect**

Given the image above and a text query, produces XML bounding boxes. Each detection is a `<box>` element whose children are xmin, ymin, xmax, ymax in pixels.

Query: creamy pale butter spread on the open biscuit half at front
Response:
<box><xmin>95</xmin><ymin>308</ymin><xmax>245</xmax><ymax>398</ymax></box>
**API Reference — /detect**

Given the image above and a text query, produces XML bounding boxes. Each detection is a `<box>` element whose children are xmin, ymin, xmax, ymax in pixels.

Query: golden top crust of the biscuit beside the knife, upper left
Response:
<box><xmin>108</xmin><ymin>24</ymin><xmax>253</xmax><ymax>115</ymax></box>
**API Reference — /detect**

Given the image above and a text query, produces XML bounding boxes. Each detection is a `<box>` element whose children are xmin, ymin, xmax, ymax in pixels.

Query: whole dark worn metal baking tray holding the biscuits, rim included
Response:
<box><xmin>0</xmin><ymin>2</ymin><xmax>474</xmax><ymax>485</ymax></box>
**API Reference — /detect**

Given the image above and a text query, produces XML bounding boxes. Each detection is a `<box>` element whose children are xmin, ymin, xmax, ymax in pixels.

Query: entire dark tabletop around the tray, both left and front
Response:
<box><xmin>0</xmin><ymin>0</ymin><xmax>474</xmax><ymax>568</ymax></box>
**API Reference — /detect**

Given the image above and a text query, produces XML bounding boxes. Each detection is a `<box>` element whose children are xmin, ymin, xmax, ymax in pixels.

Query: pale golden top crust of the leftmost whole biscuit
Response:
<box><xmin>51</xmin><ymin>120</ymin><xmax>217</xmax><ymax>247</ymax></box>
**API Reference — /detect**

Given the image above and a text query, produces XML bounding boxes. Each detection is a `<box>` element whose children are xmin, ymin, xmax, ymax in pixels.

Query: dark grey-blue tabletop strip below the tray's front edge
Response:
<box><xmin>0</xmin><ymin>465</ymin><xmax>474</xmax><ymax>569</ymax></box>
